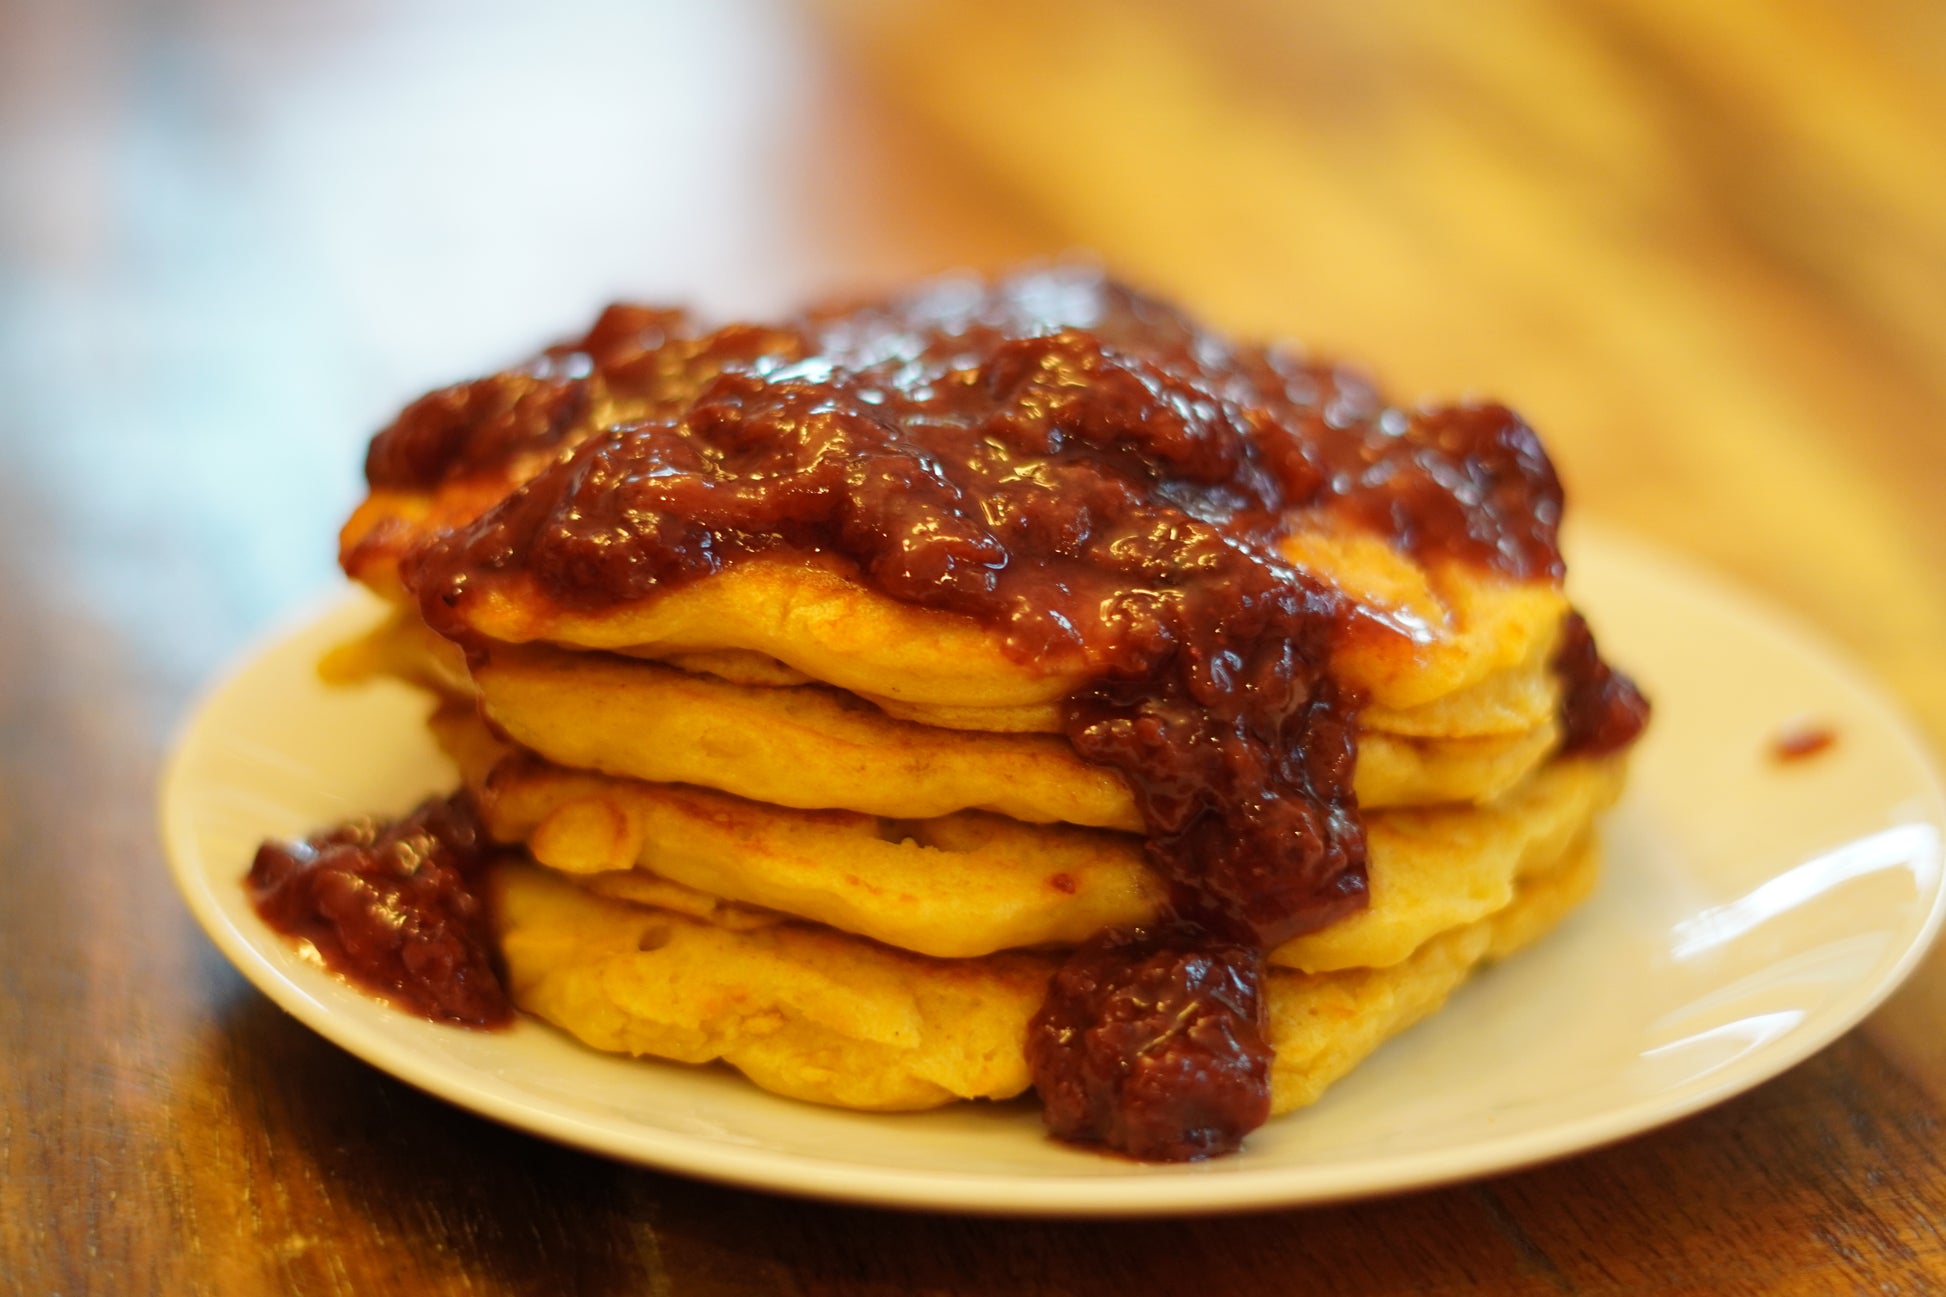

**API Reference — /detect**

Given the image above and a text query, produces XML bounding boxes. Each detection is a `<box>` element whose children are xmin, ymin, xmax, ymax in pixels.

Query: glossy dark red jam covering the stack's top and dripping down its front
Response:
<box><xmin>350</xmin><ymin>267</ymin><xmax>1607</xmax><ymax>1157</ymax></box>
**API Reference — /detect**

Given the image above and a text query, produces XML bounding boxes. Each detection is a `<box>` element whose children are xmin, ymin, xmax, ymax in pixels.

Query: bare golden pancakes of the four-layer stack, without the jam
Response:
<box><xmin>329</xmin><ymin>494</ymin><xmax>1621</xmax><ymax>1112</ymax></box>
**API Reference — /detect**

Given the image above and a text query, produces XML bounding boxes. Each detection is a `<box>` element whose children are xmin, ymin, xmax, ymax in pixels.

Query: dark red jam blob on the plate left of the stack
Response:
<box><xmin>247</xmin><ymin>793</ymin><xmax>514</xmax><ymax>1026</ymax></box>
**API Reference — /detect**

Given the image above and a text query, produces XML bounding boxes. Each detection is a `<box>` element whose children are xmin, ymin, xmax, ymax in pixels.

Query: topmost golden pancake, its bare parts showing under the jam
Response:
<box><xmin>341</xmin><ymin>518</ymin><xmax>1568</xmax><ymax>716</ymax></box>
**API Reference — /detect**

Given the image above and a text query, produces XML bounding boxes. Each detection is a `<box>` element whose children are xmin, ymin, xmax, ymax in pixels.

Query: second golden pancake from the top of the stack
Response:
<box><xmin>331</xmin><ymin>617</ymin><xmax>1559</xmax><ymax>814</ymax></box>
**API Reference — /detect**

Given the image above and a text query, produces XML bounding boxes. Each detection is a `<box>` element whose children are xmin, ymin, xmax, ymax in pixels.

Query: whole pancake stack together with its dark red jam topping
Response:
<box><xmin>247</xmin><ymin>265</ymin><xmax>1648</xmax><ymax>1161</ymax></box>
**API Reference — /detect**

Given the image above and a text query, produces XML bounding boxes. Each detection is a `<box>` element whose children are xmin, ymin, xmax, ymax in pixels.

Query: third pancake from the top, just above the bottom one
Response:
<box><xmin>434</xmin><ymin>709</ymin><xmax>1621</xmax><ymax>972</ymax></box>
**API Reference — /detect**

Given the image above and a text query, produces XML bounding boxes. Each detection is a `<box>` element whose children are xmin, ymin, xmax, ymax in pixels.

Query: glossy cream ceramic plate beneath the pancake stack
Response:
<box><xmin>162</xmin><ymin>536</ymin><xmax>1946</xmax><ymax>1215</ymax></box>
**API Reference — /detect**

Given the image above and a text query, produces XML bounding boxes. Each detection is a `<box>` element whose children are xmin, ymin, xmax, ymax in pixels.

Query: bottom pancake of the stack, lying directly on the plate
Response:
<box><xmin>490</xmin><ymin>843</ymin><xmax>1596</xmax><ymax>1112</ymax></box>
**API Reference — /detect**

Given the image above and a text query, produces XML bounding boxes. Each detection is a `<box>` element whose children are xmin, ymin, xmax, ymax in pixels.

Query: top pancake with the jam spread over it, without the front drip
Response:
<box><xmin>341</xmin><ymin>267</ymin><xmax>1567</xmax><ymax>736</ymax></box>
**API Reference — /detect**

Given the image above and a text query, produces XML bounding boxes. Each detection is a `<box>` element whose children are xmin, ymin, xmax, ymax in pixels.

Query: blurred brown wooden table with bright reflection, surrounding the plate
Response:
<box><xmin>0</xmin><ymin>0</ymin><xmax>1946</xmax><ymax>1293</ymax></box>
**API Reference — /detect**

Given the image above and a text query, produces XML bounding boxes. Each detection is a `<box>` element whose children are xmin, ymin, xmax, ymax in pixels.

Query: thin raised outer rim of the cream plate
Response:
<box><xmin>158</xmin><ymin>526</ymin><xmax>1946</xmax><ymax>1219</ymax></box>
